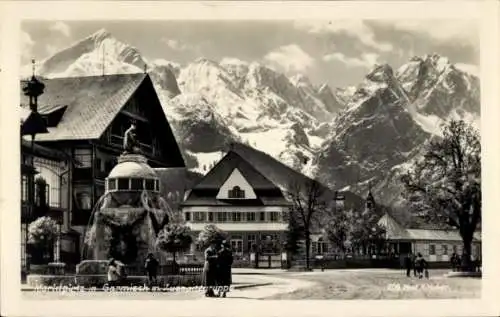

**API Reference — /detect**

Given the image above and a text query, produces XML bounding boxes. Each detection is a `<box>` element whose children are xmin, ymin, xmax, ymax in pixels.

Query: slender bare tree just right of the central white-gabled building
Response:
<box><xmin>288</xmin><ymin>180</ymin><xmax>326</xmax><ymax>269</ymax></box>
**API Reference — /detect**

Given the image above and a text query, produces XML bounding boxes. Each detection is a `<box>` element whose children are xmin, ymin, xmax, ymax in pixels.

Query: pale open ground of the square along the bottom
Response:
<box><xmin>23</xmin><ymin>269</ymin><xmax>481</xmax><ymax>300</ymax></box>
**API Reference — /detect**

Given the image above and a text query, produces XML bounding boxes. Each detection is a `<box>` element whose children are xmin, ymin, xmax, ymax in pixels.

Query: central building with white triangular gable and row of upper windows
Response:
<box><xmin>182</xmin><ymin>150</ymin><xmax>291</xmax><ymax>267</ymax></box>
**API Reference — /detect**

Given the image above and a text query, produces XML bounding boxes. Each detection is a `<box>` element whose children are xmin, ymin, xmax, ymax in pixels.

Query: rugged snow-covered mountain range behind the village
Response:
<box><xmin>22</xmin><ymin>30</ymin><xmax>480</xmax><ymax>207</ymax></box>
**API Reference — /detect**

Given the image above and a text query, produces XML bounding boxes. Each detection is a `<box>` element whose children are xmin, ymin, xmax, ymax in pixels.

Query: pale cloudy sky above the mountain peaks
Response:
<box><xmin>21</xmin><ymin>19</ymin><xmax>479</xmax><ymax>87</ymax></box>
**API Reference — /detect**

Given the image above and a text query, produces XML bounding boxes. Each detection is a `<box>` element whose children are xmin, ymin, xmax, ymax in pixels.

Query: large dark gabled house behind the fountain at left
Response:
<box><xmin>21</xmin><ymin>73</ymin><xmax>185</xmax><ymax>253</ymax></box>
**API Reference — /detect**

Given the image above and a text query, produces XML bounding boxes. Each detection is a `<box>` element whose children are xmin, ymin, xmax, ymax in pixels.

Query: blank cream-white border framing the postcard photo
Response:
<box><xmin>0</xmin><ymin>1</ymin><xmax>500</xmax><ymax>317</ymax></box>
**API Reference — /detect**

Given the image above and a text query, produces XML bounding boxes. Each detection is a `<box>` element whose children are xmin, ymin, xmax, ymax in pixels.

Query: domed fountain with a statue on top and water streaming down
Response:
<box><xmin>83</xmin><ymin>125</ymin><xmax>172</xmax><ymax>266</ymax></box>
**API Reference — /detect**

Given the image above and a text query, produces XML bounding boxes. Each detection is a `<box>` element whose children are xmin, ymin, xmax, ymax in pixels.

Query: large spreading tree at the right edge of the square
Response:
<box><xmin>401</xmin><ymin>121</ymin><xmax>481</xmax><ymax>268</ymax></box>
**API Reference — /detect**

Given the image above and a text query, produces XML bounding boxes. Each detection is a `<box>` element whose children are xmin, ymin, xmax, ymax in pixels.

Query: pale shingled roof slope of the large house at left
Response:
<box><xmin>21</xmin><ymin>73</ymin><xmax>148</xmax><ymax>141</ymax></box>
